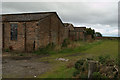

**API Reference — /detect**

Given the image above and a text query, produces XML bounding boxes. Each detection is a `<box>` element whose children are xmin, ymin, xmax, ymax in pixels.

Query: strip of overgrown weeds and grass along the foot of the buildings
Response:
<box><xmin>34</xmin><ymin>40</ymin><xmax>102</xmax><ymax>55</ymax></box>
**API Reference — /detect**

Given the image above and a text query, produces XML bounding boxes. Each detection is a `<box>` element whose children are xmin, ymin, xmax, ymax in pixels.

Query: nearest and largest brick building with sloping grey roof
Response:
<box><xmin>2</xmin><ymin>12</ymin><xmax>65</xmax><ymax>51</ymax></box>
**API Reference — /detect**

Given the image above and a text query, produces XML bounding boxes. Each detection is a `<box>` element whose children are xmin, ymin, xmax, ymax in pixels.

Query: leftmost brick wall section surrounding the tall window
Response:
<box><xmin>3</xmin><ymin>22</ymin><xmax>25</xmax><ymax>51</ymax></box>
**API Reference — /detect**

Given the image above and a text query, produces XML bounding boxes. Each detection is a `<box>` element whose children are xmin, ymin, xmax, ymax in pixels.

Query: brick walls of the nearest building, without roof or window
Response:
<box><xmin>3</xmin><ymin>14</ymin><xmax>65</xmax><ymax>51</ymax></box>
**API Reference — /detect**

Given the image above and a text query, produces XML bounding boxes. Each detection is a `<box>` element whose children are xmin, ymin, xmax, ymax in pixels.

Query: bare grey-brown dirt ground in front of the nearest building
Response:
<box><xmin>2</xmin><ymin>53</ymin><xmax>51</xmax><ymax>78</ymax></box>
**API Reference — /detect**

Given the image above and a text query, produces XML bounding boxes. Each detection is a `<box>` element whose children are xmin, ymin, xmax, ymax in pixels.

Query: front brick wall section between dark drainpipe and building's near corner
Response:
<box><xmin>25</xmin><ymin>21</ymin><xmax>36</xmax><ymax>51</ymax></box>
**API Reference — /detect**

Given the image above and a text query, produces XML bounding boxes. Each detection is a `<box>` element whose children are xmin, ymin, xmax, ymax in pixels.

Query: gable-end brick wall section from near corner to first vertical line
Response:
<box><xmin>36</xmin><ymin>17</ymin><xmax>51</xmax><ymax>48</ymax></box>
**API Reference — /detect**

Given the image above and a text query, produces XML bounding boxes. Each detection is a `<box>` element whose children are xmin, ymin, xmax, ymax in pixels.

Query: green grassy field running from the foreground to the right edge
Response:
<box><xmin>38</xmin><ymin>40</ymin><xmax>118</xmax><ymax>78</ymax></box>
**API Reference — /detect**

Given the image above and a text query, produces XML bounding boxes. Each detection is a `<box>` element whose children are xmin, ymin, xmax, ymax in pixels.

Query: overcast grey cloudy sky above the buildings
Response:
<box><xmin>2</xmin><ymin>0</ymin><xmax>118</xmax><ymax>36</ymax></box>
